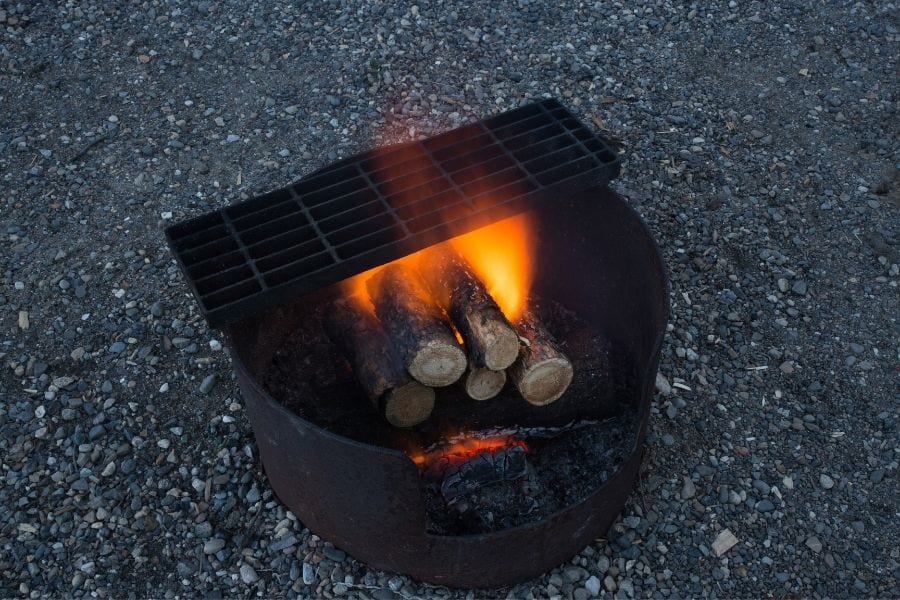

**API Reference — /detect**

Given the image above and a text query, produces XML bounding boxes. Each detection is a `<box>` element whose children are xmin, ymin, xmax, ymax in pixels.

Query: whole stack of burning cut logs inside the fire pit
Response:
<box><xmin>324</xmin><ymin>248</ymin><xmax>573</xmax><ymax>427</ymax></box>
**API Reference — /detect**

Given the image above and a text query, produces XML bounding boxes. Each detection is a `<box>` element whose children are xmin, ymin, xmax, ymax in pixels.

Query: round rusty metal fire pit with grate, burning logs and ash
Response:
<box><xmin>166</xmin><ymin>100</ymin><xmax>668</xmax><ymax>587</ymax></box>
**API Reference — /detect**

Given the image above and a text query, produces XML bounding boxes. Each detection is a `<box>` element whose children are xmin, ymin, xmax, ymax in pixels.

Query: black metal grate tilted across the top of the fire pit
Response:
<box><xmin>166</xmin><ymin>100</ymin><xmax>619</xmax><ymax>327</ymax></box>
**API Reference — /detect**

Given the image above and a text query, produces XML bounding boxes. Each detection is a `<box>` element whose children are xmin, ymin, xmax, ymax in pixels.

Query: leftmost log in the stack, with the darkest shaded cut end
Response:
<box><xmin>323</xmin><ymin>299</ymin><xmax>434</xmax><ymax>427</ymax></box>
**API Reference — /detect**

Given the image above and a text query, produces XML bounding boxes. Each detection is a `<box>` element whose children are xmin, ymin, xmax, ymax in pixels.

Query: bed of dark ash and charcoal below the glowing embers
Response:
<box><xmin>425</xmin><ymin>415</ymin><xmax>636</xmax><ymax>535</ymax></box>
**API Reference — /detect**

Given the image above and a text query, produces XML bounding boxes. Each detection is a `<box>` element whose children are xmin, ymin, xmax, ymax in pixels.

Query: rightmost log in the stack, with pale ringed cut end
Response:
<box><xmin>508</xmin><ymin>311</ymin><xmax>573</xmax><ymax>406</ymax></box>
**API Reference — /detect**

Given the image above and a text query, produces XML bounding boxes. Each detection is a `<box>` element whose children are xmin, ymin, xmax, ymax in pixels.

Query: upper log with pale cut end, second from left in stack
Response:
<box><xmin>366</xmin><ymin>264</ymin><xmax>467</xmax><ymax>387</ymax></box>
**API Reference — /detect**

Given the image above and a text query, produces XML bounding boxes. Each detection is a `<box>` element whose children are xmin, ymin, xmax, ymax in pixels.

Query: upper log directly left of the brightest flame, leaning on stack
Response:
<box><xmin>419</xmin><ymin>248</ymin><xmax>519</xmax><ymax>371</ymax></box>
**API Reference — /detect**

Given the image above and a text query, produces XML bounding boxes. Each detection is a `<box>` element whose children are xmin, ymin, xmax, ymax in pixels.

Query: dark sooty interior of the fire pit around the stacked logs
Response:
<box><xmin>233</xmin><ymin>193</ymin><xmax>662</xmax><ymax>535</ymax></box>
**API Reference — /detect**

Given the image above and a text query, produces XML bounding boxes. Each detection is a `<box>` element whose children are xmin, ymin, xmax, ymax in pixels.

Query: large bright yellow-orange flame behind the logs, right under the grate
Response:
<box><xmin>450</xmin><ymin>213</ymin><xmax>535</xmax><ymax>321</ymax></box>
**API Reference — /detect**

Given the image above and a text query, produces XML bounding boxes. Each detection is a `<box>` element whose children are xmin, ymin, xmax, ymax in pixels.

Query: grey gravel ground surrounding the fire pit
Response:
<box><xmin>0</xmin><ymin>0</ymin><xmax>900</xmax><ymax>599</ymax></box>
